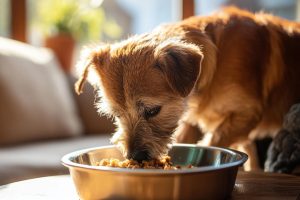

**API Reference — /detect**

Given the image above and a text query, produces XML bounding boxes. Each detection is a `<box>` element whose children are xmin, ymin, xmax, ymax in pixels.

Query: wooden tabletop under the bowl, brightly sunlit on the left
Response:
<box><xmin>0</xmin><ymin>172</ymin><xmax>300</xmax><ymax>200</ymax></box>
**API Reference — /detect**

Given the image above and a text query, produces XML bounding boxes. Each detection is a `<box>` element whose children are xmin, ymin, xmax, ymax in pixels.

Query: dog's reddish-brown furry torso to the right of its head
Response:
<box><xmin>177</xmin><ymin>7</ymin><xmax>300</xmax><ymax>141</ymax></box>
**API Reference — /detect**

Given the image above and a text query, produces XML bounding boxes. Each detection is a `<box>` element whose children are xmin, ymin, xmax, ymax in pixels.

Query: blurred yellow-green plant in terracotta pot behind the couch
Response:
<box><xmin>36</xmin><ymin>0</ymin><xmax>121</xmax><ymax>71</ymax></box>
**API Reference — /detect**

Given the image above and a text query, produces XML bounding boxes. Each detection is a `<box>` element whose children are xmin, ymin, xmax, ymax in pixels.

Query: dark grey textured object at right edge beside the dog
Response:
<box><xmin>265</xmin><ymin>104</ymin><xmax>300</xmax><ymax>173</ymax></box>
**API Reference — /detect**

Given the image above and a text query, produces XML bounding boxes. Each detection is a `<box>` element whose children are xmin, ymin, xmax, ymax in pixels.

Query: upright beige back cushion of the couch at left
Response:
<box><xmin>0</xmin><ymin>38</ymin><xmax>82</xmax><ymax>146</ymax></box>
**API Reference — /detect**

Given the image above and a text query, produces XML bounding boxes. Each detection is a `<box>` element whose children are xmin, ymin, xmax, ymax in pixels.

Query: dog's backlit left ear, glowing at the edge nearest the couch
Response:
<box><xmin>75</xmin><ymin>45</ymin><xmax>110</xmax><ymax>94</ymax></box>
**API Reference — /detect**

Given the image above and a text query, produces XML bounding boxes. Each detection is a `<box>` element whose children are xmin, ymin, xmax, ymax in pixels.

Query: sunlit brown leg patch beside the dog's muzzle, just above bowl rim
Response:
<box><xmin>175</xmin><ymin>122</ymin><xmax>202</xmax><ymax>143</ymax></box>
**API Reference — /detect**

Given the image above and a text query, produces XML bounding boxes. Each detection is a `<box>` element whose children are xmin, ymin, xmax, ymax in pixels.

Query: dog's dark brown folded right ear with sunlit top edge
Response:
<box><xmin>154</xmin><ymin>39</ymin><xmax>203</xmax><ymax>97</ymax></box>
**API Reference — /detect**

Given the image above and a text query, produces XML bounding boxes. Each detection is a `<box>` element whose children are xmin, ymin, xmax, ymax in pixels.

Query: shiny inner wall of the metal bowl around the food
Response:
<box><xmin>70</xmin><ymin>145</ymin><xmax>247</xmax><ymax>167</ymax></box>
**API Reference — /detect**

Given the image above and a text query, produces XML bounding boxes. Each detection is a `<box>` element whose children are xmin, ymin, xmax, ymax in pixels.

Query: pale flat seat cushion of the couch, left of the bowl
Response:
<box><xmin>0</xmin><ymin>134</ymin><xmax>110</xmax><ymax>185</ymax></box>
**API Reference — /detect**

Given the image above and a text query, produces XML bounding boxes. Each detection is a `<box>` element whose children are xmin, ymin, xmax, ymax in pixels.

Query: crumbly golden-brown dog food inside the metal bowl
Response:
<box><xmin>96</xmin><ymin>156</ymin><xmax>193</xmax><ymax>170</ymax></box>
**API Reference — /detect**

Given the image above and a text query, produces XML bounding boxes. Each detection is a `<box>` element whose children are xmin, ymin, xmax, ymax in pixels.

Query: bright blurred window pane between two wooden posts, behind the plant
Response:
<box><xmin>27</xmin><ymin>0</ymin><xmax>181</xmax><ymax>46</ymax></box>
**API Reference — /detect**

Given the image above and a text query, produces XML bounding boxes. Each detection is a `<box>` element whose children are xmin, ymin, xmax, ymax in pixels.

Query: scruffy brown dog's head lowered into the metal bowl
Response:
<box><xmin>76</xmin><ymin>34</ymin><xmax>203</xmax><ymax>160</ymax></box>
